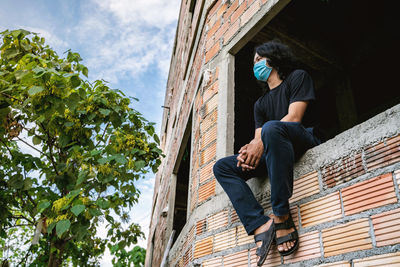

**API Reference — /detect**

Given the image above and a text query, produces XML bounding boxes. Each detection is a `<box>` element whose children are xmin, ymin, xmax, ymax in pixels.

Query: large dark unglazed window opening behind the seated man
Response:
<box><xmin>235</xmin><ymin>0</ymin><xmax>400</xmax><ymax>149</ymax></box>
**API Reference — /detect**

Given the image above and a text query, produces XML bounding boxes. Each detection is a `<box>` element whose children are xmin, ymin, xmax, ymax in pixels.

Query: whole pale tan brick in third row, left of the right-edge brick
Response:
<box><xmin>322</xmin><ymin>219</ymin><xmax>372</xmax><ymax>257</ymax></box>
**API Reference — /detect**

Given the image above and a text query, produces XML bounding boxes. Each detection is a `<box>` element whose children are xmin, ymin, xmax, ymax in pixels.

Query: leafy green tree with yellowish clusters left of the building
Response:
<box><xmin>0</xmin><ymin>30</ymin><xmax>162</xmax><ymax>267</ymax></box>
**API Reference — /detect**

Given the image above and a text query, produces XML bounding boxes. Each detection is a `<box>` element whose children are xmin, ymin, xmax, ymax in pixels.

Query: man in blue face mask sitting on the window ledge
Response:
<box><xmin>214</xmin><ymin>41</ymin><xmax>320</xmax><ymax>266</ymax></box>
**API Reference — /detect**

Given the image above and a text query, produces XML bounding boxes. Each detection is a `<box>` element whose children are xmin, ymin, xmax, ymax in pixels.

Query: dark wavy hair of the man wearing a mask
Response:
<box><xmin>255</xmin><ymin>39</ymin><xmax>297</xmax><ymax>80</ymax></box>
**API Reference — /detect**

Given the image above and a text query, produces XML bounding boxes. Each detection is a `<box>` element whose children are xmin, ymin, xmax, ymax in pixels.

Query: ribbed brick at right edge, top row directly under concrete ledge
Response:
<box><xmin>365</xmin><ymin>135</ymin><xmax>400</xmax><ymax>170</ymax></box>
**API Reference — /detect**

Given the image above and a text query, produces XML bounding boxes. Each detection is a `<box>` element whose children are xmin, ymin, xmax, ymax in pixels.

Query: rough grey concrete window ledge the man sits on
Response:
<box><xmin>170</xmin><ymin>104</ymin><xmax>400</xmax><ymax>260</ymax></box>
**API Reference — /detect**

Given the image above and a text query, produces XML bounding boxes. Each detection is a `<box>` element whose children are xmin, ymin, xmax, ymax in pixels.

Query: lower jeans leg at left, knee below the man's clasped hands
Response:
<box><xmin>213</xmin><ymin>155</ymin><xmax>270</xmax><ymax>235</ymax></box>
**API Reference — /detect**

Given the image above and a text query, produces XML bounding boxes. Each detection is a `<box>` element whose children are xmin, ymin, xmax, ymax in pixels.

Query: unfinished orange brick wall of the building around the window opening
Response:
<box><xmin>146</xmin><ymin>0</ymin><xmax>400</xmax><ymax>267</ymax></box>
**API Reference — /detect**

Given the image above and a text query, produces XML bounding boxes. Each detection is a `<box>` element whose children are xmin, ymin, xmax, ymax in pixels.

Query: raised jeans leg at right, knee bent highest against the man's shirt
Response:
<box><xmin>261</xmin><ymin>121</ymin><xmax>318</xmax><ymax>216</ymax></box>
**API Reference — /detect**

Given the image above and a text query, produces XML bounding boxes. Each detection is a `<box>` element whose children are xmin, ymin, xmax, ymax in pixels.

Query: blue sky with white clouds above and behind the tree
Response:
<box><xmin>0</xmin><ymin>0</ymin><xmax>180</xmax><ymax>266</ymax></box>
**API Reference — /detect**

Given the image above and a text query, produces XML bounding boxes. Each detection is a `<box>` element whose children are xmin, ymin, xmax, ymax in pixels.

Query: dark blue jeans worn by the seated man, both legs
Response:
<box><xmin>214</xmin><ymin>121</ymin><xmax>321</xmax><ymax>235</ymax></box>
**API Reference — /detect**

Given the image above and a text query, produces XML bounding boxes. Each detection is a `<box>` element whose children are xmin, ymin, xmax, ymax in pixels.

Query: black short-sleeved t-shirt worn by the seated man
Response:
<box><xmin>254</xmin><ymin>69</ymin><xmax>315</xmax><ymax>129</ymax></box>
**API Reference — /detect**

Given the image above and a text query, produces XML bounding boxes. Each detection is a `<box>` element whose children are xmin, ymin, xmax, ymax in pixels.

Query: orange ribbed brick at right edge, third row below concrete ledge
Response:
<box><xmin>372</xmin><ymin>209</ymin><xmax>400</xmax><ymax>247</ymax></box>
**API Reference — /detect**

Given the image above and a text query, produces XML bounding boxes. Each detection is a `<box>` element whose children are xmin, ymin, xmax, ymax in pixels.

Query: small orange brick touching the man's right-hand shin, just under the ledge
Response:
<box><xmin>290</xmin><ymin>171</ymin><xmax>319</xmax><ymax>203</ymax></box>
